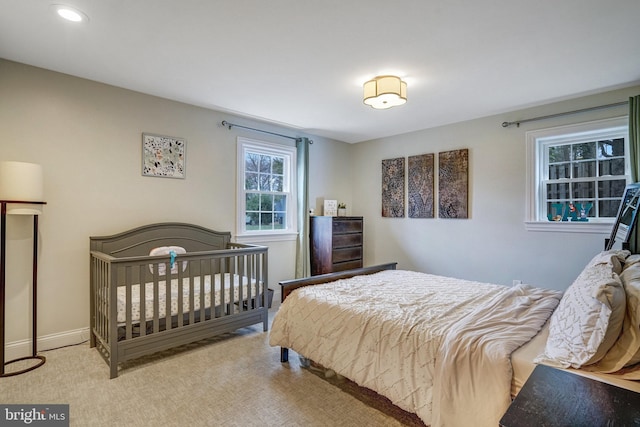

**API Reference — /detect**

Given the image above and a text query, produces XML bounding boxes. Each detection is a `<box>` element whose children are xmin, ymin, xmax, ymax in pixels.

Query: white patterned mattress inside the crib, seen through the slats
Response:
<box><xmin>118</xmin><ymin>273</ymin><xmax>262</xmax><ymax>324</ymax></box>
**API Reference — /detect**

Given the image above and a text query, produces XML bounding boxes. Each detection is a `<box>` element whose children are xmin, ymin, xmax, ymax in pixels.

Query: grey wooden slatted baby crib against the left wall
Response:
<box><xmin>90</xmin><ymin>222</ymin><xmax>273</xmax><ymax>378</ymax></box>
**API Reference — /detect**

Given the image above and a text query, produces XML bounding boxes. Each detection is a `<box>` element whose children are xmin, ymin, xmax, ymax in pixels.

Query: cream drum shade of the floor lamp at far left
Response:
<box><xmin>0</xmin><ymin>161</ymin><xmax>44</xmax><ymax>215</ymax></box>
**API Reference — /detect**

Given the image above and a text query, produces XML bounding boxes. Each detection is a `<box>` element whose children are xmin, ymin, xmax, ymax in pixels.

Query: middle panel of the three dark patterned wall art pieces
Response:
<box><xmin>407</xmin><ymin>153</ymin><xmax>434</xmax><ymax>218</ymax></box>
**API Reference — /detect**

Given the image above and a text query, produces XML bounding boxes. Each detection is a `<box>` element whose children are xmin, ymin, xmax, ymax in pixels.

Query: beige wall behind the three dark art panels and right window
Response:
<box><xmin>352</xmin><ymin>87</ymin><xmax>640</xmax><ymax>290</ymax></box>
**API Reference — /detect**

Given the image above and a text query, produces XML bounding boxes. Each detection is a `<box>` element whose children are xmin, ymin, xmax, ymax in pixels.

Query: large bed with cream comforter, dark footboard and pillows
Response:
<box><xmin>269</xmin><ymin>250</ymin><xmax>640</xmax><ymax>426</ymax></box>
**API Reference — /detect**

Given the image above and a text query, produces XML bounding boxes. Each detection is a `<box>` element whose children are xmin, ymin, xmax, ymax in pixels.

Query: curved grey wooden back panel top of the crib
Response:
<box><xmin>89</xmin><ymin>222</ymin><xmax>231</xmax><ymax>258</ymax></box>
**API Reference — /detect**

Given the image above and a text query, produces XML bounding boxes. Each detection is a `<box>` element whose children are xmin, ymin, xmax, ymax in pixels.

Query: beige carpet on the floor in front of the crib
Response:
<box><xmin>0</xmin><ymin>314</ymin><xmax>412</xmax><ymax>426</ymax></box>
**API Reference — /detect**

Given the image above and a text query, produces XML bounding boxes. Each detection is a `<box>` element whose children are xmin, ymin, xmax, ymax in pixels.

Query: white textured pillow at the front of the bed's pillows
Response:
<box><xmin>535</xmin><ymin>250</ymin><xmax>629</xmax><ymax>368</ymax></box>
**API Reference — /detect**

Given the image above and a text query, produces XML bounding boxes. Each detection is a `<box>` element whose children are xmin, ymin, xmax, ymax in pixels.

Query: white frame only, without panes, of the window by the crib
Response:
<box><xmin>236</xmin><ymin>137</ymin><xmax>298</xmax><ymax>242</ymax></box>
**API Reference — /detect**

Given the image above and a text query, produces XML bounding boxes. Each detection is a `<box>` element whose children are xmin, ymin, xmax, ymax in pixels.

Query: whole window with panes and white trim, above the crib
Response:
<box><xmin>238</xmin><ymin>138</ymin><xmax>297</xmax><ymax>239</ymax></box>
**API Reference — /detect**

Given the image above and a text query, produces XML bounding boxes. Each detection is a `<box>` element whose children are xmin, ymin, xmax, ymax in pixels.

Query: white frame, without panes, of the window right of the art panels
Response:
<box><xmin>525</xmin><ymin>116</ymin><xmax>631</xmax><ymax>234</ymax></box>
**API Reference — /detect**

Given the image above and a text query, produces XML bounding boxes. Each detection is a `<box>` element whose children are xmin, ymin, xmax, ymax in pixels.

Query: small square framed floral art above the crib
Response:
<box><xmin>142</xmin><ymin>133</ymin><xmax>187</xmax><ymax>178</ymax></box>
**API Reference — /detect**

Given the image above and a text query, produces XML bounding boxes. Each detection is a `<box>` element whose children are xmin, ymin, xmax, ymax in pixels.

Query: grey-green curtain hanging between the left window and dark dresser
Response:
<box><xmin>296</xmin><ymin>138</ymin><xmax>311</xmax><ymax>278</ymax></box>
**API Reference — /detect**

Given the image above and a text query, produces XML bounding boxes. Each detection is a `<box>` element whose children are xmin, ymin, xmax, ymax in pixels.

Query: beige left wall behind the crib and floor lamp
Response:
<box><xmin>0</xmin><ymin>60</ymin><xmax>351</xmax><ymax>348</ymax></box>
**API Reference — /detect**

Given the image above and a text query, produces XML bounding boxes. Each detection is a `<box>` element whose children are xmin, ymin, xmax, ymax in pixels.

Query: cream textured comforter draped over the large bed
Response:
<box><xmin>270</xmin><ymin>270</ymin><xmax>561</xmax><ymax>426</ymax></box>
